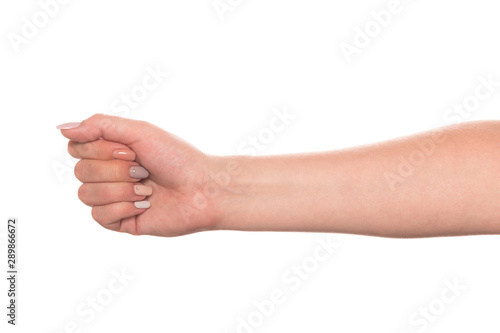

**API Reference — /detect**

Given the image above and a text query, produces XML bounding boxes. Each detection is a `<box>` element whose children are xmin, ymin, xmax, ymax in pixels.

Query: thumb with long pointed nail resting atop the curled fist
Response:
<box><xmin>56</xmin><ymin>113</ymin><xmax>151</xmax><ymax>145</ymax></box>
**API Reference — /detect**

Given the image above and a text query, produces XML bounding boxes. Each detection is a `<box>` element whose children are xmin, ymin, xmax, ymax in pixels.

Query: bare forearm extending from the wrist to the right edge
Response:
<box><xmin>215</xmin><ymin>121</ymin><xmax>500</xmax><ymax>237</ymax></box>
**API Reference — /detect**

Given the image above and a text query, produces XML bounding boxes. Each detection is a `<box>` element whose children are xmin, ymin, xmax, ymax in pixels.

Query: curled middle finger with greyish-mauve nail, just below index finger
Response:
<box><xmin>74</xmin><ymin>159</ymin><xmax>149</xmax><ymax>183</ymax></box>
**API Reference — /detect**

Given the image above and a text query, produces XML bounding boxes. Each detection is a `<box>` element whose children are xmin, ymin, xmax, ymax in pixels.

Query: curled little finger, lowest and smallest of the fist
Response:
<box><xmin>92</xmin><ymin>201</ymin><xmax>149</xmax><ymax>231</ymax></box>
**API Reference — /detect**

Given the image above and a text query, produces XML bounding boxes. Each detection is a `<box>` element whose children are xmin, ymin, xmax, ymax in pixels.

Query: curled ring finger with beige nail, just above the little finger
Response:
<box><xmin>78</xmin><ymin>183</ymin><xmax>153</xmax><ymax>206</ymax></box>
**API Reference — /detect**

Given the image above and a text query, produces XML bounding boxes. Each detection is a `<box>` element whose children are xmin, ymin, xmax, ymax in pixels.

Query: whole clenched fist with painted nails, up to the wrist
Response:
<box><xmin>61</xmin><ymin>114</ymin><xmax>216</xmax><ymax>236</ymax></box>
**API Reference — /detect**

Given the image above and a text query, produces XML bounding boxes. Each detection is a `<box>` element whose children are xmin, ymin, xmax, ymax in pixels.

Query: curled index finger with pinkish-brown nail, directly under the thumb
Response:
<box><xmin>68</xmin><ymin>140</ymin><xmax>135</xmax><ymax>161</ymax></box>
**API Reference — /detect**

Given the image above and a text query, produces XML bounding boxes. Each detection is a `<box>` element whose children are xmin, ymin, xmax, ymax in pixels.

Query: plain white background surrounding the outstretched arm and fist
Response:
<box><xmin>0</xmin><ymin>0</ymin><xmax>500</xmax><ymax>333</ymax></box>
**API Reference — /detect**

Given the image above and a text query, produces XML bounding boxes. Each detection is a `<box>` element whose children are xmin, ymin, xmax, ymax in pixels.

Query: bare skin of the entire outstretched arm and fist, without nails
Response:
<box><xmin>61</xmin><ymin>114</ymin><xmax>500</xmax><ymax>237</ymax></box>
